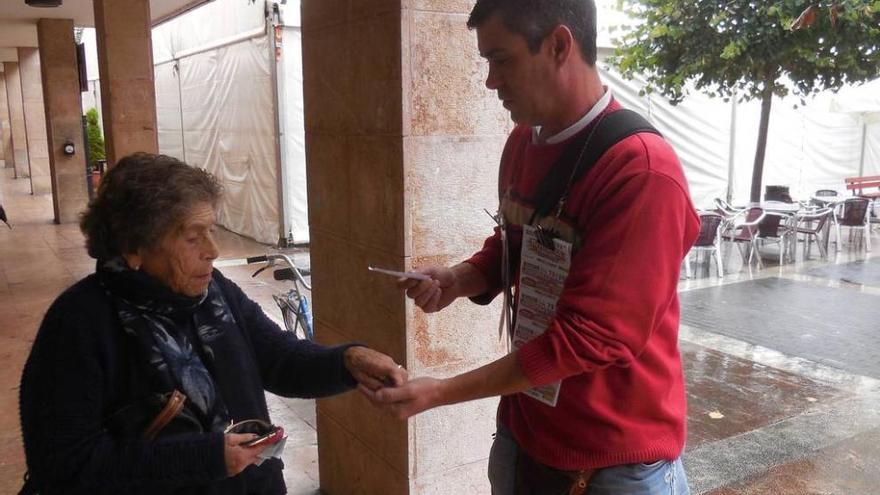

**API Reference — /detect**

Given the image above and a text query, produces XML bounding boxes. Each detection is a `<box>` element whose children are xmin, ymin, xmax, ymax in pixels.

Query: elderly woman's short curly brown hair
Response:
<box><xmin>80</xmin><ymin>153</ymin><xmax>222</xmax><ymax>260</ymax></box>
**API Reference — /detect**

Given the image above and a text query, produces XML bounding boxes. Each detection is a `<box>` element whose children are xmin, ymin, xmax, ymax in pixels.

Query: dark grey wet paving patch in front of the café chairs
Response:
<box><xmin>681</xmin><ymin>278</ymin><xmax>880</xmax><ymax>378</ymax></box>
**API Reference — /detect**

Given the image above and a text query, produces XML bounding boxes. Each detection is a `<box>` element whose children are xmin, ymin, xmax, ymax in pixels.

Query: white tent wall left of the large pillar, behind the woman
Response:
<box><xmin>153</xmin><ymin>0</ymin><xmax>308</xmax><ymax>243</ymax></box>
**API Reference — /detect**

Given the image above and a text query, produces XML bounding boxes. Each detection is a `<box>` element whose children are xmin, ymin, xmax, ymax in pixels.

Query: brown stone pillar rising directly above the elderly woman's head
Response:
<box><xmin>94</xmin><ymin>0</ymin><xmax>159</xmax><ymax>164</ymax></box>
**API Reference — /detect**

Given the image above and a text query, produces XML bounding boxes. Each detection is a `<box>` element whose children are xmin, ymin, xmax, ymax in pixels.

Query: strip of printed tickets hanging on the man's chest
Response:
<box><xmin>513</xmin><ymin>225</ymin><xmax>571</xmax><ymax>407</ymax></box>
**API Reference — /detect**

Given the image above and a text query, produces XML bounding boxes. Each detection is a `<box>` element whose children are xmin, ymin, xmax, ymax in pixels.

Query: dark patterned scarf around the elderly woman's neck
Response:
<box><xmin>97</xmin><ymin>257</ymin><xmax>236</xmax><ymax>431</ymax></box>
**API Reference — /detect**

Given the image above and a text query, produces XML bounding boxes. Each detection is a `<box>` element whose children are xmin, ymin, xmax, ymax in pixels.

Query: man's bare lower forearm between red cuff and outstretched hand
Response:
<box><xmin>439</xmin><ymin>352</ymin><xmax>532</xmax><ymax>405</ymax></box>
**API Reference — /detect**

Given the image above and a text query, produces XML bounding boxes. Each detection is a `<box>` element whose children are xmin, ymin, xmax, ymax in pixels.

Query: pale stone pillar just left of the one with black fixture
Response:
<box><xmin>18</xmin><ymin>48</ymin><xmax>52</xmax><ymax>194</ymax></box>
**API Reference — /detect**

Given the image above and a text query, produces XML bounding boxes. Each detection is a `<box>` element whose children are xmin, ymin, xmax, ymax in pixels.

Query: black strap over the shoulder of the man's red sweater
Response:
<box><xmin>532</xmin><ymin>109</ymin><xmax>662</xmax><ymax>219</ymax></box>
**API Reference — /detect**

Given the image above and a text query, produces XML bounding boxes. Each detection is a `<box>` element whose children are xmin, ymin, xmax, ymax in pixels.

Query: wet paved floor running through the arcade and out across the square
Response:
<box><xmin>0</xmin><ymin>165</ymin><xmax>880</xmax><ymax>495</ymax></box>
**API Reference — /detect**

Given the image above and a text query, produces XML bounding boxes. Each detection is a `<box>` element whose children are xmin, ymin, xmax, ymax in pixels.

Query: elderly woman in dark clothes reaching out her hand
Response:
<box><xmin>21</xmin><ymin>154</ymin><xmax>406</xmax><ymax>494</ymax></box>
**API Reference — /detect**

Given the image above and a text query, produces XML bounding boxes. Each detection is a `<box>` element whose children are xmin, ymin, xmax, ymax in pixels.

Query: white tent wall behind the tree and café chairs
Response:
<box><xmin>600</xmin><ymin>66</ymin><xmax>880</xmax><ymax>207</ymax></box>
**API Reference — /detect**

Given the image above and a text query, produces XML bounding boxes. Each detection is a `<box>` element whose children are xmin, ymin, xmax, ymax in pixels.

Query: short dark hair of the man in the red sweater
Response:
<box><xmin>468</xmin><ymin>0</ymin><xmax>596</xmax><ymax>65</ymax></box>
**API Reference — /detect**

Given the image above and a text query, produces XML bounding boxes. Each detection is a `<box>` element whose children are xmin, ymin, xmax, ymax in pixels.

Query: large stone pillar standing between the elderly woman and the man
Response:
<box><xmin>302</xmin><ymin>0</ymin><xmax>510</xmax><ymax>495</ymax></box>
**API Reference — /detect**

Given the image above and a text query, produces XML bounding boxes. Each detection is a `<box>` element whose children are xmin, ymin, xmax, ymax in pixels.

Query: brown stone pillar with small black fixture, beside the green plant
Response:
<box><xmin>37</xmin><ymin>19</ymin><xmax>89</xmax><ymax>223</ymax></box>
